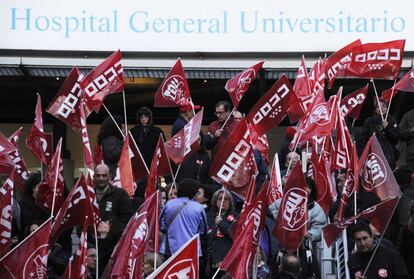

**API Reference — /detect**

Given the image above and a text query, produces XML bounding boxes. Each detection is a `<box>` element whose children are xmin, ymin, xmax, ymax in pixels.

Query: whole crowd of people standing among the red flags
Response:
<box><xmin>3</xmin><ymin>97</ymin><xmax>414</xmax><ymax>279</ymax></box>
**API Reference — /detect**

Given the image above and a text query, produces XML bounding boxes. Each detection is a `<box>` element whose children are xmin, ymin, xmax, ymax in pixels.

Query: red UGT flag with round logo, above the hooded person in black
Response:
<box><xmin>154</xmin><ymin>59</ymin><xmax>191</xmax><ymax>107</ymax></box>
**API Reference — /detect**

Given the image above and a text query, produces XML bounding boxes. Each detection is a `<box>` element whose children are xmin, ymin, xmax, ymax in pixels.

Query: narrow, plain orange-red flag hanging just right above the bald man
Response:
<box><xmin>118</xmin><ymin>137</ymin><xmax>136</xmax><ymax>197</ymax></box>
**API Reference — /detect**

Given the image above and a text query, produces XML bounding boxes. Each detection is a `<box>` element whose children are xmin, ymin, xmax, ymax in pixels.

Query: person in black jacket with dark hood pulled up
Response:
<box><xmin>131</xmin><ymin>107</ymin><xmax>165</xmax><ymax>169</ymax></box>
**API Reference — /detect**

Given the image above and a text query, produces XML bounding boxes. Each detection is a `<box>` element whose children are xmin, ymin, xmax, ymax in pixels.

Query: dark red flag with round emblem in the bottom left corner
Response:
<box><xmin>0</xmin><ymin>218</ymin><xmax>51</xmax><ymax>278</ymax></box>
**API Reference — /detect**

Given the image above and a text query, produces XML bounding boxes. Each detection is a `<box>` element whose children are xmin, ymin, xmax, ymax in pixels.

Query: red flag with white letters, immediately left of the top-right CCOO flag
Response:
<box><xmin>325</xmin><ymin>39</ymin><xmax>361</xmax><ymax>89</ymax></box>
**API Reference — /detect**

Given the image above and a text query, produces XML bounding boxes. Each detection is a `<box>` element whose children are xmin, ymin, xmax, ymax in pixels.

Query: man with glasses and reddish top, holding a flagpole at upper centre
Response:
<box><xmin>206</xmin><ymin>101</ymin><xmax>238</xmax><ymax>160</ymax></box>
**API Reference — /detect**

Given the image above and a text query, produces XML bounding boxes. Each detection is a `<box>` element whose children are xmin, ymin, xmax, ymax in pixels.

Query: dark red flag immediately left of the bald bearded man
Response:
<box><xmin>50</xmin><ymin>174</ymin><xmax>96</xmax><ymax>243</ymax></box>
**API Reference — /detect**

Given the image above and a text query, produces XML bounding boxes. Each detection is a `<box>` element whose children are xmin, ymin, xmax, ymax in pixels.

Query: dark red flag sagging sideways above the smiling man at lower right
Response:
<box><xmin>323</xmin><ymin>197</ymin><xmax>400</xmax><ymax>247</ymax></box>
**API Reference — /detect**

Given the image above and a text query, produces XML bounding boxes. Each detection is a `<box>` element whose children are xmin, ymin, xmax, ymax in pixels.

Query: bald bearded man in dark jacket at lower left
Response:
<box><xmin>94</xmin><ymin>164</ymin><xmax>132</xmax><ymax>274</ymax></box>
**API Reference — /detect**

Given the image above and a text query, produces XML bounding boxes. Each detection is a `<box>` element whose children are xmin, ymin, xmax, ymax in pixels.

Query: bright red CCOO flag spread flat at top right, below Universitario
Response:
<box><xmin>345</xmin><ymin>40</ymin><xmax>405</xmax><ymax>79</ymax></box>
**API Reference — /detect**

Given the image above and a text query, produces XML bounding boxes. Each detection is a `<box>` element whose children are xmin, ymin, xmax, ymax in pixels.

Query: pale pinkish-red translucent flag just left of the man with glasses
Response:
<box><xmin>165</xmin><ymin>109</ymin><xmax>203</xmax><ymax>165</ymax></box>
